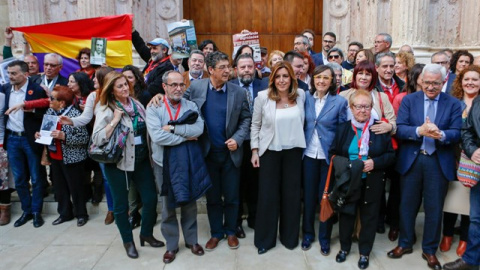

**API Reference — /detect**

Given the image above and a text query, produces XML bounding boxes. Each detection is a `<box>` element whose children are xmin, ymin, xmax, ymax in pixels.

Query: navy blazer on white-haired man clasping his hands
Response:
<box><xmin>396</xmin><ymin>91</ymin><xmax>462</xmax><ymax>181</ymax></box>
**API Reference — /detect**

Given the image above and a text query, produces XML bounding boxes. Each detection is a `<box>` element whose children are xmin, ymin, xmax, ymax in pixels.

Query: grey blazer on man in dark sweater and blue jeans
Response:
<box><xmin>184</xmin><ymin>79</ymin><xmax>252</xmax><ymax>168</ymax></box>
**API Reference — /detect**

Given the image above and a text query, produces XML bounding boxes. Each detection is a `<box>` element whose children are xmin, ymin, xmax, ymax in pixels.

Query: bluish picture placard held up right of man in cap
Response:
<box><xmin>167</xmin><ymin>20</ymin><xmax>198</xmax><ymax>59</ymax></box>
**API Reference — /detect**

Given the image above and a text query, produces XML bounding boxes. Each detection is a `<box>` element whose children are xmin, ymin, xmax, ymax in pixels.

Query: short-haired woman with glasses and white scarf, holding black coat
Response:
<box><xmin>329</xmin><ymin>89</ymin><xmax>395</xmax><ymax>269</ymax></box>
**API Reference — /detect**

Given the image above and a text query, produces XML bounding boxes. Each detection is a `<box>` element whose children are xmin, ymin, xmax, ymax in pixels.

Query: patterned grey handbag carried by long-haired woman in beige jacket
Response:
<box><xmin>88</xmin><ymin>123</ymin><xmax>130</xmax><ymax>163</ymax></box>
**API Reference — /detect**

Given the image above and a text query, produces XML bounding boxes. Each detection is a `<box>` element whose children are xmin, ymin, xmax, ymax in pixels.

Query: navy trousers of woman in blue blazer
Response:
<box><xmin>302</xmin><ymin>156</ymin><xmax>333</xmax><ymax>245</ymax></box>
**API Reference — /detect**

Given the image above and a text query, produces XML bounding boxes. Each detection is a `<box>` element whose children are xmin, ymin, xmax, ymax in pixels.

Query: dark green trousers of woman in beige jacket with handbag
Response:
<box><xmin>105</xmin><ymin>159</ymin><xmax>157</xmax><ymax>243</ymax></box>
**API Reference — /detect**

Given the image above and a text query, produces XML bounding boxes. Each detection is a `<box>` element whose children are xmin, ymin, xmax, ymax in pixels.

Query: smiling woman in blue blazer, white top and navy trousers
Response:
<box><xmin>302</xmin><ymin>66</ymin><xmax>348</xmax><ymax>253</ymax></box>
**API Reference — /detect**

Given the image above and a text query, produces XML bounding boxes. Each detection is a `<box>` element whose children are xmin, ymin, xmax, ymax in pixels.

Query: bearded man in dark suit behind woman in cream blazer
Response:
<box><xmin>230</xmin><ymin>54</ymin><xmax>268</xmax><ymax>238</ymax></box>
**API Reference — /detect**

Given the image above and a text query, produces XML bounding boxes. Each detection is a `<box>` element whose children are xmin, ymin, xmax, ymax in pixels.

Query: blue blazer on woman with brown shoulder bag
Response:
<box><xmin>304</xmin><ymin>92</ymin><xmax>348</xmax><ymax>164</ymax></box>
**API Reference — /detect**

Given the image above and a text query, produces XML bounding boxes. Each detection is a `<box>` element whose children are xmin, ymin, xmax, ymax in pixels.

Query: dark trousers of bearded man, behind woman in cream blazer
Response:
<box><xmin>237</xmin><ymin>140</ymin><xmax>258</xmax><ymax>228</ymax></box>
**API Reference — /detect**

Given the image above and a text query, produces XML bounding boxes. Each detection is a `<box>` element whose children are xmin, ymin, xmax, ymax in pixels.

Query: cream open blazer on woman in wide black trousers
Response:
<box><xmin>250</xmin><ymin>88</ymin><xmax>305</xmax><ymax>156</ymax></box>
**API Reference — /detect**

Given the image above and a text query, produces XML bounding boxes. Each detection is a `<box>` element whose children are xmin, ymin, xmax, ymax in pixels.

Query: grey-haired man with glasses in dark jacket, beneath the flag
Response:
<box><xmin>32</xmin><ymin>53</ymin><xmax>68</xmax><ymax>93</ymax></box>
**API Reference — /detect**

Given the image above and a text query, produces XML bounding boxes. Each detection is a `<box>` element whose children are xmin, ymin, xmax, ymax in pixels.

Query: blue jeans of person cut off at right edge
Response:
<box><xmin>463</xmin><ymin>184</ymin><xmax>480</xmax><ymax>265</ymax></box>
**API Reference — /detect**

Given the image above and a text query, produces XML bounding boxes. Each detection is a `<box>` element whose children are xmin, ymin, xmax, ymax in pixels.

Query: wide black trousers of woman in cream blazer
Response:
<box><xmin>255</xmin><ymin>148</ymin><xmax>303</xmax><ymax>249</ymax></box>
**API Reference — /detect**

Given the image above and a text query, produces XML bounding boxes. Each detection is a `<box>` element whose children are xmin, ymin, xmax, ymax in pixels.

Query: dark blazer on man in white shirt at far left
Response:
<box><xmin>1</xmin><ymin>80</ymin><xmax>48</xmax><ymax>154</ymax></box>
